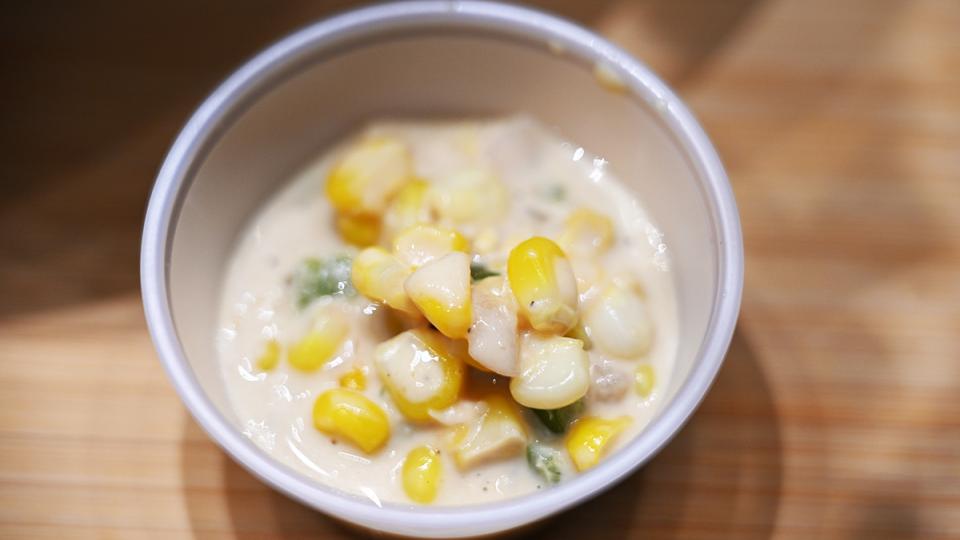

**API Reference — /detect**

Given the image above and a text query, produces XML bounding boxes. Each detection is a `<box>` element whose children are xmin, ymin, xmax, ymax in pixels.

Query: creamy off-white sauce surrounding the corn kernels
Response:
<box><xmin>216</xmin><ymin>117</ymin><xmax>677</xmax><ymax>505</ymax></box>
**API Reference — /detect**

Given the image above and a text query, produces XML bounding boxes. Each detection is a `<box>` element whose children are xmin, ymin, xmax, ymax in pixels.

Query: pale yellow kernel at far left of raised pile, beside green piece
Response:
<box><xmin>350</xmin><ymin>247</ymin><xmax>419</xmax><ymax>315</ymax></box>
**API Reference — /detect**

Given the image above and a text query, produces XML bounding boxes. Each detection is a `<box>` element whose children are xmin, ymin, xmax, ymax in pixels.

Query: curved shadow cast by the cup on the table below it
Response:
<box><xmin>182</xmin><ymin>326</ymin><xmax>781</xmax><ymax>540</ymax></box>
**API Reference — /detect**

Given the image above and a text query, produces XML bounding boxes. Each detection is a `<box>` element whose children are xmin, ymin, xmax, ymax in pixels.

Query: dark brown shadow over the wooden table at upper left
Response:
<box><xmin>0</xmin><ymin>0</ymin><xmax>351</xmax><ymax>320</ymax></box>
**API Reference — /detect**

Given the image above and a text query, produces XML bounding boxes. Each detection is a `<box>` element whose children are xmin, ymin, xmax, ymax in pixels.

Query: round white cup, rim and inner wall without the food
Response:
<box><xmin>141</xmin><ymin>1</ymin><xmax>743</xmax><ymax>537</ymax></box>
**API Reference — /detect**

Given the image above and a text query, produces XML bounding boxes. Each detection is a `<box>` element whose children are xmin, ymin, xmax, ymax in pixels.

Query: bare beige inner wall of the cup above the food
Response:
<box><xmin>156</xmin><ymin>12</ymin><xmax>720</xmax><ymax>534</ymax></box>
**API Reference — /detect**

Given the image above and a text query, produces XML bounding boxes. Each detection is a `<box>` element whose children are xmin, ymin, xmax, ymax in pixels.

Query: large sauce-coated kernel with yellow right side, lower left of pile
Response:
<box><xmin>374</xmin><ymin>328</ymin><xmax>466</xmax><ymax>422</ymax></box>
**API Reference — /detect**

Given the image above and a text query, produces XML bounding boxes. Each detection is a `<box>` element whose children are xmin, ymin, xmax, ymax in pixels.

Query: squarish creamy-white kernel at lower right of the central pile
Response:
<box><xmin>510</xmin><ymin>332</ymin><xmax>590</xmax><ymax>409</ymax></box>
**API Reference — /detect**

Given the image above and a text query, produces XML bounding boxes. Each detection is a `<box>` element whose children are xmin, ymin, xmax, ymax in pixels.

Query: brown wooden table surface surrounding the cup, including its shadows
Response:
<box><xmin>0</xmin><ymin>0</ymin><xmax>960</xmax><ymax>540</ymax></box>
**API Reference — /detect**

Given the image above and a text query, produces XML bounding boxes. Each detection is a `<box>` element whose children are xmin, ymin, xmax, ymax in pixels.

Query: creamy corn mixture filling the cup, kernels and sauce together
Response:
<box><xmin>216</xmin><ymin>116</ymin><xmax>677</xmax><ymax>505</ymax></box>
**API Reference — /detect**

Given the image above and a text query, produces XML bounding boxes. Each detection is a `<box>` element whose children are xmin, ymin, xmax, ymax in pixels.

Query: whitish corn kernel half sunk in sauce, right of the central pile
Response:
<box><xmin>583</xmin><ymin>284</ymin><xmax>654</xmax><ymax>358</ymax></box>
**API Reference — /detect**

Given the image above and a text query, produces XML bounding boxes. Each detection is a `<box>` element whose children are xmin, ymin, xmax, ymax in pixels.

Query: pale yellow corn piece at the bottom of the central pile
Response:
<box><xmin>450</xmin><ymin>394</ymin><xmax>527</xmax><ymax>469</ymax></box>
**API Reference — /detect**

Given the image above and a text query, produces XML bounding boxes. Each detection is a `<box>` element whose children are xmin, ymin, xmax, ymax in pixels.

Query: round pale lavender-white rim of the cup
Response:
<box><xmin>140</xmin><ymin>0</ymin><xmax>743</xmax><ymax>537</ymax></box>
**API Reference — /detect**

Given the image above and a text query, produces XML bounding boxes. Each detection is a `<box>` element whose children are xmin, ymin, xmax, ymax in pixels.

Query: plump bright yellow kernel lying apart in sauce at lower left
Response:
<box><xmin>313</xmin><ymin>388</ymin><xmax>390</xmax><ymax>454</ymax></box>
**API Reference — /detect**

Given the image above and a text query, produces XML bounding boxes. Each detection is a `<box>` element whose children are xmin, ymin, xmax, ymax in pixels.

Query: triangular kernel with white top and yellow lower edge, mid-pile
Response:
<box><xmin>403</xmin><ymin>251</ymin><xmax>473</xmax><ymax>338</ymax></box>
